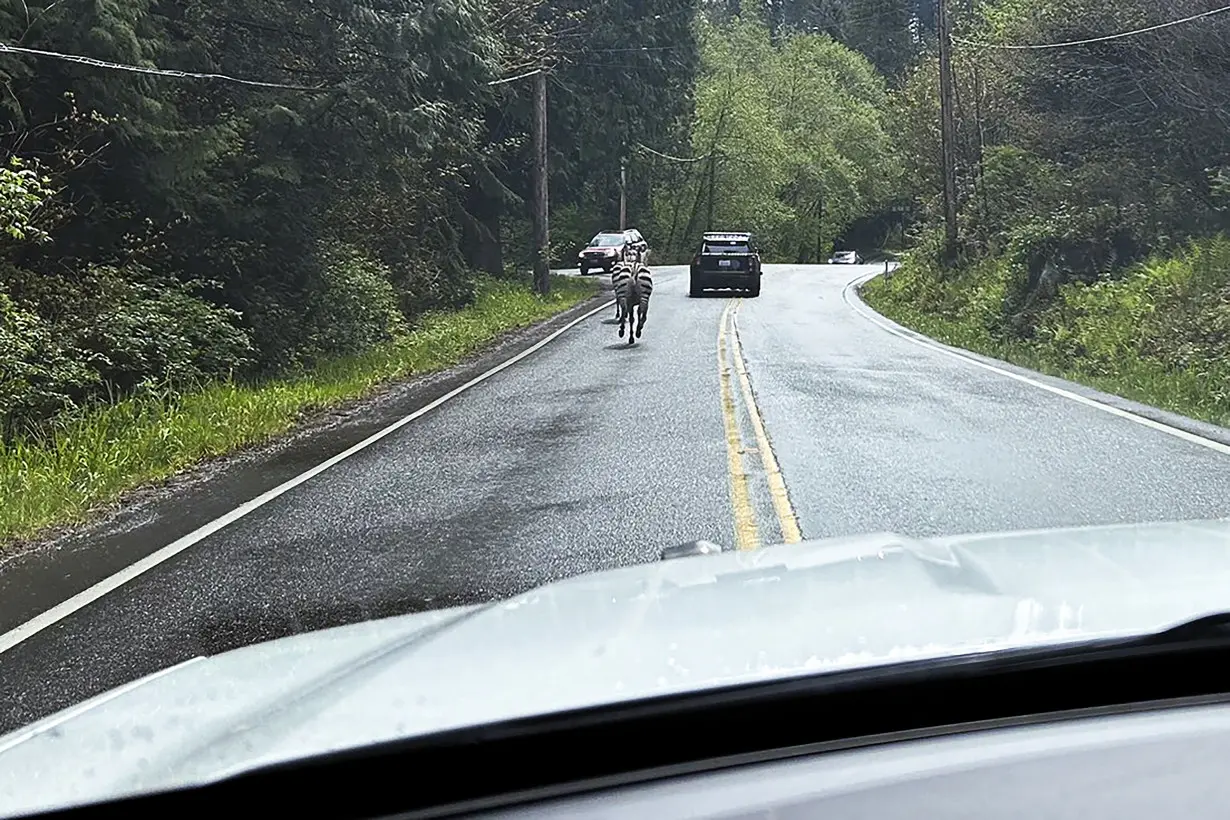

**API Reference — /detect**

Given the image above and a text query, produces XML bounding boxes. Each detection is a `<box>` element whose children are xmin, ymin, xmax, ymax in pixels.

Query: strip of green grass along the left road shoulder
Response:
<box><xmin>0</xmin><ymin>277</ymin><xmax>597</xmax><ymax>546</ymax></box>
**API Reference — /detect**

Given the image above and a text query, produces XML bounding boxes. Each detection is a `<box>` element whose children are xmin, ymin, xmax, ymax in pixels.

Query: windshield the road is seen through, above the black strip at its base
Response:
<box><xmin>0</xmin><ymin>0</ymin><xmax>1230</xmax><ymax>814</ymax></box>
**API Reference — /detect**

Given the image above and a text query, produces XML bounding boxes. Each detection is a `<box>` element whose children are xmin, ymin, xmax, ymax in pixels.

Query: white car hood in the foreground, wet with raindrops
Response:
<box><xmin>0</xmin><ymin>520</ymin><xmax>1230</xmax><ymax>815</ymax></box>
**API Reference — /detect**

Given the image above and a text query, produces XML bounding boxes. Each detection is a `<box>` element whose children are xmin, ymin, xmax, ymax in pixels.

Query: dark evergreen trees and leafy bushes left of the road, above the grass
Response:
<box><xmin>0</xmin><ymin>0</ymin><xmax>654</xmax><ymax>436</ymax></box>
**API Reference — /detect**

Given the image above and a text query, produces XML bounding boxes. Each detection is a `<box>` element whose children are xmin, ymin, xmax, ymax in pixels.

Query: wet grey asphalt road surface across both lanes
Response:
<box><xmin>0</xmin><ymin>266</ymin><xmax>1230</xmax><ymax>730</ymax></box>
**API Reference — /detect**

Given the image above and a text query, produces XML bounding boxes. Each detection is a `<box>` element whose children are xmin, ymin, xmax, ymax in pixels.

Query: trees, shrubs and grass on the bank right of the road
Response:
<box><xmin>890</xmin><ymin>0</ymin><xmax>1230</xmax><ymax>408</ymax></box>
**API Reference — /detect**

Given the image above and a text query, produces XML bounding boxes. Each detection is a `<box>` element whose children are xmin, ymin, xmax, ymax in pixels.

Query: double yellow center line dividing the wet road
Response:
<box><xmin>717</xmin><ymin>299</ymin><xmax>803</xmax><ymax>550</ymax></box>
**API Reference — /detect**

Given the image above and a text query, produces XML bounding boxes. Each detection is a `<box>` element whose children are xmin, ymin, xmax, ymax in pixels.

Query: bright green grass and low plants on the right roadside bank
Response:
<box><xmin>862</xmin><ymin>237</ymin><xmax>1230</xmax><ymax>427</ymax></box>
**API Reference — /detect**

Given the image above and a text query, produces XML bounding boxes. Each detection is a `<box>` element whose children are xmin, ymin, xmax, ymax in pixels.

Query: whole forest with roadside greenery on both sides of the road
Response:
<box><xmin>0</xmin><ymin>0</ymin><xmax>1230</xmax><ymax>538</ymax></box>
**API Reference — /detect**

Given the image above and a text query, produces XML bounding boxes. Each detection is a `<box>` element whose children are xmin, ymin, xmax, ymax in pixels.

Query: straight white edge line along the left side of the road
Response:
<box><xmin>0</xmin><ymin>300</ymin><xmax>615</xmax><ymax>654</ymax></box>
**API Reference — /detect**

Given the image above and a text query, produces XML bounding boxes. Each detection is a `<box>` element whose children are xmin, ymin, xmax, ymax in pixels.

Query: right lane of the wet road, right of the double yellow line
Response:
<box><xmin>738</xmin><ymin>266</ymin><xmax>1230</xmax><ymax>542</ymax></box>
